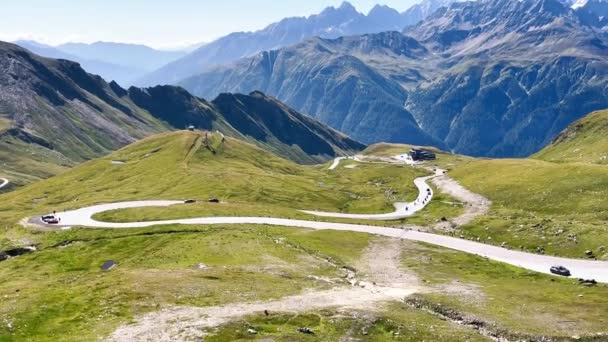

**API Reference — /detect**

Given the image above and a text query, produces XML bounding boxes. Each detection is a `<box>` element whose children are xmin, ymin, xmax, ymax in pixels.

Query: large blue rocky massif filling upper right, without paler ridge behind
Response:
<box><xmin>180</xmin><ymin>0</ymin><xmax>608</xmax><ymax>157</ymax></box>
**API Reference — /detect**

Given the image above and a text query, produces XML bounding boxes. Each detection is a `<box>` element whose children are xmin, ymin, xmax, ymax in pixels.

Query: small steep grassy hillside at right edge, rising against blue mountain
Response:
<box><xmin>533</xmin><ymin>110</ymin><xmax>608</xmax><ymax>165</ymax></box>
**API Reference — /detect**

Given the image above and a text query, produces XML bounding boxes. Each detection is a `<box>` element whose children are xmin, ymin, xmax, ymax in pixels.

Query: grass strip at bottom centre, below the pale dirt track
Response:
<box><xmin>205</xmin><ymin>303</ymin><xmax>488</xmax><ymax>341</ymax></box>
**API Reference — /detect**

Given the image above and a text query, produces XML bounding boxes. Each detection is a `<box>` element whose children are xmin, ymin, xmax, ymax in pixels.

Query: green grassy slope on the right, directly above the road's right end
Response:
<box><xmin>451</xmin><ymin>159</ymin><xmax>608</xmax><ymax>259</ymax></box>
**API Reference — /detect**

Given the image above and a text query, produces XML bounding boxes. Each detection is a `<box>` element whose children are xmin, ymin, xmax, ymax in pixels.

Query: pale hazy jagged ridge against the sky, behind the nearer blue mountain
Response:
<box><xmin>137</xmin><ymin>0</ymin><xmax>453</xmax><ymax>86</ymax></box>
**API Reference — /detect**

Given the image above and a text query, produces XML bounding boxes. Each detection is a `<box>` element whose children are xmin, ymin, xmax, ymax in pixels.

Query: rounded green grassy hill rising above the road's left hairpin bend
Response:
<box><xmin>0</xmin><ymin>131</ymin><xmax>444</xmax><ymax>232</ymax></box>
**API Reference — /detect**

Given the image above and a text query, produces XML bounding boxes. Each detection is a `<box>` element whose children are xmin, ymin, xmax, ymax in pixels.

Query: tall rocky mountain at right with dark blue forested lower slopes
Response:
<box><xmin>405</xmin><ymin>0</ymin><xmax>608</xmax><ymax>157</ymax></box>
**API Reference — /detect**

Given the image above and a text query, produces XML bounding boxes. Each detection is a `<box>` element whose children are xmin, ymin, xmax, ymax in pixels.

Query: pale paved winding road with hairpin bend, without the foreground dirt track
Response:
<box><xmin>30</xmin><ymin>159</ymin><xmax>608</xmax><ymax>283</ymax></box>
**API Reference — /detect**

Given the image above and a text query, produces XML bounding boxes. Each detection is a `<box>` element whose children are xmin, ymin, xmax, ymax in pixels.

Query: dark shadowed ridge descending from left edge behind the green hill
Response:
<box><xmin>0</xmin><ymin>43</ymin><xmax>364</xmax><ymax>182</ymax></box>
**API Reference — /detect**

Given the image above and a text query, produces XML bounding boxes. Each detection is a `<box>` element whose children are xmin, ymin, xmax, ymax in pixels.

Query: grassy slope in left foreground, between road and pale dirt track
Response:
<box><xmin>0</xmin><ymin>226</ymin><xmax>369</xmax><ymax>341</ymax></box>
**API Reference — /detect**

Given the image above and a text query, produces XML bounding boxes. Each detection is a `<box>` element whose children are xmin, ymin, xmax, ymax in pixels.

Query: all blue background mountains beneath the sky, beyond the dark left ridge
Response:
<box><xmin>7</xmin><ymin>0</ymin><xmax>608</xmax><ymax>161</ymax></box>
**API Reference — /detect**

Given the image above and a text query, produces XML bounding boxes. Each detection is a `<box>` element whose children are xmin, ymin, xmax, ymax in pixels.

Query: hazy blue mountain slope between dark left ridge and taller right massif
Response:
<box><xmin>181</xmin><ymin>32</ymin><xmax>441</xmax><ymax>146</ymax></box>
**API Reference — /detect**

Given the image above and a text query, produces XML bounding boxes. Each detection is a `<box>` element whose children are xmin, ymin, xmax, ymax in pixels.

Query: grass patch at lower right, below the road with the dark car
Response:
<box><xmin>403</xmin><ymin>243</ymin><xmax>608</xmax><ymax>338</ymax></box>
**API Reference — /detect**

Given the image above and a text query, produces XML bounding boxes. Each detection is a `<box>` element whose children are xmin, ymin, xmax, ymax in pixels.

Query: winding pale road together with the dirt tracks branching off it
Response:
<box><xmin>25</xmin><ymin>158</ymin><xmax>608</xmax><ymax>341</ymax></box>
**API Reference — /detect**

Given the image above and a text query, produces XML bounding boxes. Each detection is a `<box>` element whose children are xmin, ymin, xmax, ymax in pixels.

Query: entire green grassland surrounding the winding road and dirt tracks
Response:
<box><xmin>0</xmin><ymin>127</ymin><xmax>608</xmax><ymax>341</ymax></box>
